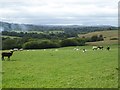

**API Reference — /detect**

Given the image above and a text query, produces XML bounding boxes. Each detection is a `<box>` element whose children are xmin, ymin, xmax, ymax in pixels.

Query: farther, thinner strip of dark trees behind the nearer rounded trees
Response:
<box><xmin>2</xmin><ymin>31</ymin><xmax>77</xmax><ymax>39</ymax></box>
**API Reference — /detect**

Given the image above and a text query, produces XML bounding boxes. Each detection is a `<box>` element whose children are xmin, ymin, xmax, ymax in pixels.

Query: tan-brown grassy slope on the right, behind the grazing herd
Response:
<box><xmin>79</xmin><ymin>30</ymin><xmax>118</xmax><ymax>45</ymax></box>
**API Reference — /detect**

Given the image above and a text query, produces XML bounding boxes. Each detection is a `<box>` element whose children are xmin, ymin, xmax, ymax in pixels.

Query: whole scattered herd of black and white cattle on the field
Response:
<box><xmin>1</xmin><ymin>46</ymin><xmax>110</xmax><ymax>60</ymax></box>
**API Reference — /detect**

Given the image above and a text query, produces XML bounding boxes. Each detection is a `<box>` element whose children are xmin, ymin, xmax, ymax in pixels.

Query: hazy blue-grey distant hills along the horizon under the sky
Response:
<box><xmin>0</xmin><ymin>21</ymin><xmax>117</xmax><ymax>33</ymax></box>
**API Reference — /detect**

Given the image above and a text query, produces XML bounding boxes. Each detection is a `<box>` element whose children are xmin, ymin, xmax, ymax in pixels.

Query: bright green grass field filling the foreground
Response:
<box><xmin>2</xmin><ymin>45</ymin><xmax>118</xmax><ymax>88</ymax></box>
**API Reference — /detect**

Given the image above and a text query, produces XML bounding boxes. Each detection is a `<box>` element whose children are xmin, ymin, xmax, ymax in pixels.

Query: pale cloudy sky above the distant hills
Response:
<box><xmin>0</xmin><ymin>0</ymin><xmax>119</xmax><ymax>26</ymax></box>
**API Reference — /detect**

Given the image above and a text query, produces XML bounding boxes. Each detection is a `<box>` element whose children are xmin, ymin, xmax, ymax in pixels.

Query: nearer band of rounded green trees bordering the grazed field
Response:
<box><xmin>2</xmin><ymin>35</ymin><xmax>104</xmax><ymax>50</ymax></box>
